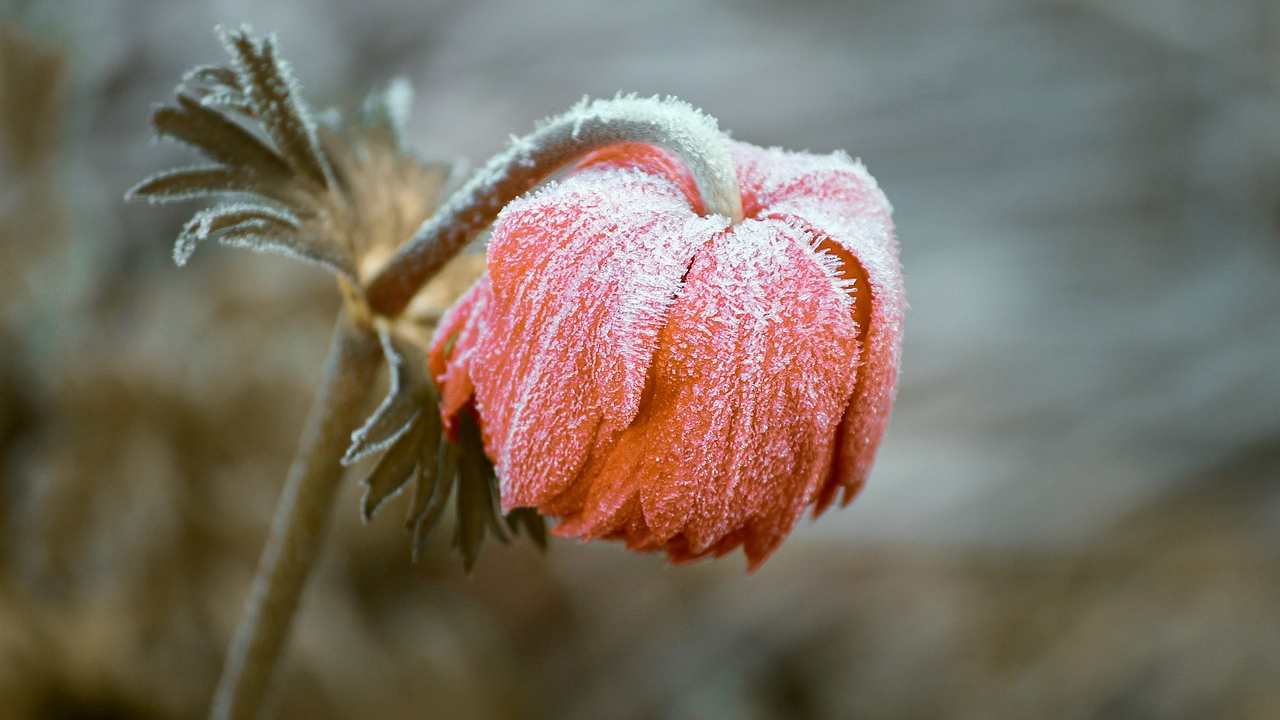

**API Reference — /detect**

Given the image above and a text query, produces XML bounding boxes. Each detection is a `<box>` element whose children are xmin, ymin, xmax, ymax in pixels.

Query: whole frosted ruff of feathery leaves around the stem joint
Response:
<box><xmin>128</xmin><ymin>27</ymin><xmax>544</xmax><ymax>569</ymax></box>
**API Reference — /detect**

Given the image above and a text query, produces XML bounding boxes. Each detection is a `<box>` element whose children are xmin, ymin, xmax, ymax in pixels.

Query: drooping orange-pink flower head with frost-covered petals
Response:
<box><xmin>429</xmin><ymin>143</ymin><xmax>904</xmax><ymax>568</ymax></box>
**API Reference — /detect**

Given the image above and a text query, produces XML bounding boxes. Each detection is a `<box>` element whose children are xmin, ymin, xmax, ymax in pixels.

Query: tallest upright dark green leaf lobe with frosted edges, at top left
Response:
<box><xmin>223</xmin><ymin>28</ymin><xmax>329</xmax><ymax>187</ymax></box>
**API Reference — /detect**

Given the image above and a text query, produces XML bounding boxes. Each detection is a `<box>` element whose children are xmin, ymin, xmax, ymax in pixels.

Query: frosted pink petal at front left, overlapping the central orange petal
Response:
<box><xmin>471</xmin><ymin>167</ymin><xmax>724</xmax><ymax>509</ymax></box>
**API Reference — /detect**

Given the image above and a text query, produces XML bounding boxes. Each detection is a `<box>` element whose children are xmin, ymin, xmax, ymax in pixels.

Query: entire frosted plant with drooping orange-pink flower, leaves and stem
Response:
<box><xmin>129</xmin><ymin>22</ymin><xmax>902</xmax><ymax>719</ymax></box>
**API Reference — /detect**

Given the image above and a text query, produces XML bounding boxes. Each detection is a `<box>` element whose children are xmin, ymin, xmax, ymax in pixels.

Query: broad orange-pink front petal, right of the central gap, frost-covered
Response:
<box><xmin>556</xmin><ymin>215</ymin><xmax>858</xmax><ymax>566</ymax></box>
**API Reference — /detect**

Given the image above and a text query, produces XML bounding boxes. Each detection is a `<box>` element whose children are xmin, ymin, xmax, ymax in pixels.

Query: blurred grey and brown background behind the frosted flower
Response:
<box><xmin>0</xmin><ymin>0</ymin><xmax>1280</xmax><ymax>719</ymax></box>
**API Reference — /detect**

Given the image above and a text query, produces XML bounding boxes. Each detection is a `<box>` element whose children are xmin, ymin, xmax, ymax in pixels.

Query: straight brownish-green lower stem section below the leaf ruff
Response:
<box><xmin>210</xmin><ymin>310</ymin><xmax>383</xmax><ymax>720</ymax></box>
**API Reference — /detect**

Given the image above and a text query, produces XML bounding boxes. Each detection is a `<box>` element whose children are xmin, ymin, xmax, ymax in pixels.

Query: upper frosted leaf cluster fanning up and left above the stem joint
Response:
<box><xmin>127</xmin><ymin>28</ymin><xmax>448</xmax><ymax>283</ymax></box>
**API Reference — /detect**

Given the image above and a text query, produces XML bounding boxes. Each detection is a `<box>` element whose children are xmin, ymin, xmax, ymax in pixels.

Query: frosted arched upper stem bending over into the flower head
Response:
<box><xmin>366</xmin><ymin>97</ymin><xmax>742</xmax><ymax>316</ymax></box>
